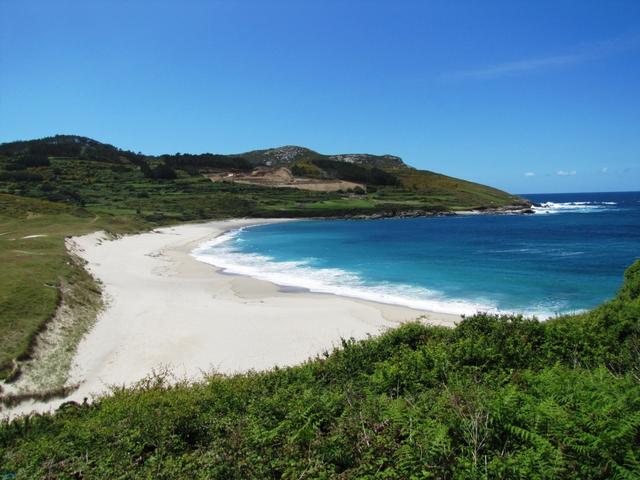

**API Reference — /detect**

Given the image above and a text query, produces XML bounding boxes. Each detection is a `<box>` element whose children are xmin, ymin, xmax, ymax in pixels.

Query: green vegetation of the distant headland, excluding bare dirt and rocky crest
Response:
<box><xmin>0</xmin><ymin>136</ymin><xmax>518</xmax><ymax>221</ymax></box>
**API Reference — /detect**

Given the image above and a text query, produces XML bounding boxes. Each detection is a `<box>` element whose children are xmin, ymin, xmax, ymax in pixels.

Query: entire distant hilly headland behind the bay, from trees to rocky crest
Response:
<box><xmin>0</xmin><ymin>135</ymin><xmax>528</xmax><ymax>222</ymax></box>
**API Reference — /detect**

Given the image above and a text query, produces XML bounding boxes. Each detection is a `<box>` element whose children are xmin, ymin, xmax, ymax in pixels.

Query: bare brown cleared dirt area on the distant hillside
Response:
<box><xmin>205</xmin><ymin>167</ymin><xmax>365</xmax><ymax>192</ymax></box>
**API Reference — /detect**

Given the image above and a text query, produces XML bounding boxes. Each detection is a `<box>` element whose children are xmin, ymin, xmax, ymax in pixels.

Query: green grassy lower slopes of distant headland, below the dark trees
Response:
<box><xmin>0</xmin><ymin>150</ymin><xmax>516</xmax><ymax>222</ymax></box>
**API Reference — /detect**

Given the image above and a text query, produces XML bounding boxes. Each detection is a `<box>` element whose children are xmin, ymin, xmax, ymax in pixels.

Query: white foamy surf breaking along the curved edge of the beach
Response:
<box><xmin>191</xmin><ymin>227</ymin><xmax>555</xmax><ymax>318</ymax></box>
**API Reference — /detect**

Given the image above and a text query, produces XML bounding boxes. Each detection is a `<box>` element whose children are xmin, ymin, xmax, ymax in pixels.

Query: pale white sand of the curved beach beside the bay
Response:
<box><xmin>5</xmin><ymin>219</ymin><xmax>460</xmax><ymax>415</ymax></box>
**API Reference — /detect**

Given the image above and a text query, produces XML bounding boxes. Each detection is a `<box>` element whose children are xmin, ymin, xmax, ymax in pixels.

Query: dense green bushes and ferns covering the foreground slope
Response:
<box><xmin>0</xmin><ymin>262</ymin><xmax>640</xmax><ymax>479</ymax></box>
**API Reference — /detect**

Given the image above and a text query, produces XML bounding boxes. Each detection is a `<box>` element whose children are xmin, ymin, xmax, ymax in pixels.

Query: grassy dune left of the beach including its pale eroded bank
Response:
<box><xmin>0</xmin><ymin>193</ymin><xmax>146</xmax><ymax>384</ymax></box>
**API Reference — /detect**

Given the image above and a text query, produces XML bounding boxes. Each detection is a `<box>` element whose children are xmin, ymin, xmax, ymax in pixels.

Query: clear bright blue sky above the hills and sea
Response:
<box><xmin>0</xmin><ymin>0</ymin><xmax>640</xmax><ymax>193</ymax></box>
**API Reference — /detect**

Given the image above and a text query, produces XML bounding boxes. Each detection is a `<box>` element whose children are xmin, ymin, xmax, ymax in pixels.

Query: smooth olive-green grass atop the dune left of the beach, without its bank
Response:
<box><xmin>0</xmin><ymin>194</ymin><xmax>145</xmax><ymax>378</ymax></box>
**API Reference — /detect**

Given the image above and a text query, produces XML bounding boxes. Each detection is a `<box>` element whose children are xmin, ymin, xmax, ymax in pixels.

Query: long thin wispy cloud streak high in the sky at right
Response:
<box><xmin>442</xmin><ymin>36</ymin><xmax>640</xmax><ymax>80</ymax></box>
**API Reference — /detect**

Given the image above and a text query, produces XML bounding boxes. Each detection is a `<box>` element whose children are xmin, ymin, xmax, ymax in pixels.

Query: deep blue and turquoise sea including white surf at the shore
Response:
<box><xmin>194</xmin><ymin>192</ymin><xmax>640</xmax><ymax>318</ymax></box>
